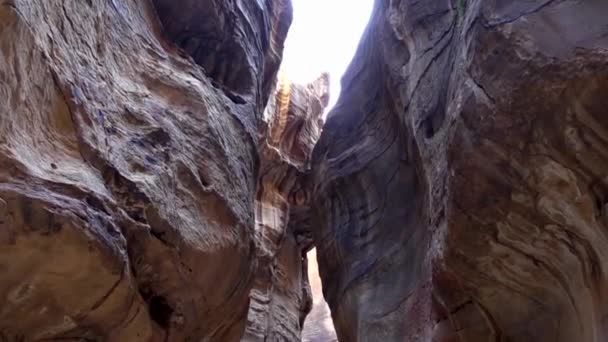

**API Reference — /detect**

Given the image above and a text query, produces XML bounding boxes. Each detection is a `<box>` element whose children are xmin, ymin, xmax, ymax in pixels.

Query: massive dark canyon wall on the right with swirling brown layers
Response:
<box><xmin>310</xmin><ymin>0</ymin><xmax>608</xmax><ymax>342</ymax></box>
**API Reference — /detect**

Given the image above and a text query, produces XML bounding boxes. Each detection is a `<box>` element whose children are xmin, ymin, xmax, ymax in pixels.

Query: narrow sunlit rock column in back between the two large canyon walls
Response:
<box><xmin>244</xmin><ymin>74</ymin><xmax>329</xmax><ymax>341</ymax></box>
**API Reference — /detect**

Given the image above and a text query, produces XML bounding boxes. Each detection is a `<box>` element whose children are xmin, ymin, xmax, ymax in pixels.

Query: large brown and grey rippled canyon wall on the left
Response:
<box><xmin>0</xmin><ymin>0</ymin><xmax>294</xmax><ymax>341</ymax></box>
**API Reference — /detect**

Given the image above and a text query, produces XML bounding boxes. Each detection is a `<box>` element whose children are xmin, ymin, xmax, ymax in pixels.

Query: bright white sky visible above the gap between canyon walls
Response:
<box><xmin>283</xmin><ymin>0</ymin><xmax>374</xmax><ymax>113</ymax></box>
